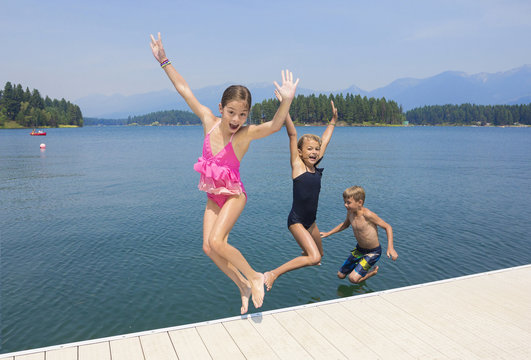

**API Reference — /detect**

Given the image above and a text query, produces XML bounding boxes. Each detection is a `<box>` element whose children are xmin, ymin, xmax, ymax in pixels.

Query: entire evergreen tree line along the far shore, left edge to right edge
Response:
<box><xmin>0</xmin><ymin>82</ymin><xmax>531</xmax><ymax>128</ymax></box>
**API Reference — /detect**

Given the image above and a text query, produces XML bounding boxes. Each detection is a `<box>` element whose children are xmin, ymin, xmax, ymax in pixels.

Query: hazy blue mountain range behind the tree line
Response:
<box><xmin>78</xmin><ymin>65</ymin><xmax>531</xmax><ymax>119</ymax></box>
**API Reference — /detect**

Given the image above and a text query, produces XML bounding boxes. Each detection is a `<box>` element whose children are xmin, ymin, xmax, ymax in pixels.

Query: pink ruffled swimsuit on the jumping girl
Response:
<box><xmin>194</xmin><ymin>121</ymin><xmax>247</xmax><ymax>209</ymax></box>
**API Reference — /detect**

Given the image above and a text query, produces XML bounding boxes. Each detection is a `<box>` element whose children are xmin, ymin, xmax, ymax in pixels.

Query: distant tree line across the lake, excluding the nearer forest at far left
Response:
<box><xmin>85</xmin><ymin>94</ymin><xmax>531</xmax><ymax>126</ymax></box>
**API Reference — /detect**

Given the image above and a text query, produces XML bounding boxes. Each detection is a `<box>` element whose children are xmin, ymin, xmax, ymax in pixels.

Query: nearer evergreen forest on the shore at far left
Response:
<box><xmin>0</xmin><ymin>81</ymin><xmax>83</xmax><ymax>128</ymax></box>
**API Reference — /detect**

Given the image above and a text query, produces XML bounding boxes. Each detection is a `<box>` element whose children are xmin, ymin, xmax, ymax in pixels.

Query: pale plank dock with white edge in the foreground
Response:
<box><xmin>0</xmin><ymin>265</ymin><xmax>531</xmax><ymax>360</ymax></box>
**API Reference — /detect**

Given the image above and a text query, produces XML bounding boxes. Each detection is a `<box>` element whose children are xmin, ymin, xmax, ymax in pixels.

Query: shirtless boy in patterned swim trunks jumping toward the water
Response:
<box><xmin>321</xmin><ymin>186</ymin><xmax>398</xmax><ymax>284</ymax></box>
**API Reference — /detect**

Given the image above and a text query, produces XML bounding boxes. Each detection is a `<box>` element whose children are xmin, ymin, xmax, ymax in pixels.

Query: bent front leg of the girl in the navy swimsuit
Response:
<box><xmin>264</xmin><ymin>224</ymin><xmax>322</xmax><ymax>291</ymax></box>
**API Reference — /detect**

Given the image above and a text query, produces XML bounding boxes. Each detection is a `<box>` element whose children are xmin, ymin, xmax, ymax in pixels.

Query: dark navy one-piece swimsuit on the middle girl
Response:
<box><xmin>288</xmin><ymin>168</ymin><xmax>323</xmax><ymax>229</ymax></box>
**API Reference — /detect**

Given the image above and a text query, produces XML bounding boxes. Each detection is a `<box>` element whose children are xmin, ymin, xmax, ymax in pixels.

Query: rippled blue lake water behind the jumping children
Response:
<box><xmin>0</xmin><ymin>126</ymin><xmax>531</xmax><ymax>353</ymax></box>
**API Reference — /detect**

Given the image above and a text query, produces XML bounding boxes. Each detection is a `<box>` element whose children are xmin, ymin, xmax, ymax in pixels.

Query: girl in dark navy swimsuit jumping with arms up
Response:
<box><xmin>264</xmin><ymin>91</ymin><xmax>337</xmax><ymax>291</ymax></box>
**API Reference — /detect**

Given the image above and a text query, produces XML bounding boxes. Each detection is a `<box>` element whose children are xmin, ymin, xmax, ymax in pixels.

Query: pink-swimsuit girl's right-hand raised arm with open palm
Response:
<box><xmin>248</xmin><ymin>70</ymin><xmax>299</xmax><ymax>140</ymax></box>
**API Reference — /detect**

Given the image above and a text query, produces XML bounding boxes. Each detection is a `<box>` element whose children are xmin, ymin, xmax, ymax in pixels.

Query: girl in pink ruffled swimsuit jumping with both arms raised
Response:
<box><xmin>151</xmin><ymin>33</ymin><xmax>299</xmax><ymax>314</ymax></box>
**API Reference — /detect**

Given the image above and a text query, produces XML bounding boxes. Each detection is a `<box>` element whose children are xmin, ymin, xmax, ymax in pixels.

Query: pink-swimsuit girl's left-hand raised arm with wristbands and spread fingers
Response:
<box><xmin>150</xmin><ymin>32</ymin><xmax>216</xmax><ymax>125</ymax></box>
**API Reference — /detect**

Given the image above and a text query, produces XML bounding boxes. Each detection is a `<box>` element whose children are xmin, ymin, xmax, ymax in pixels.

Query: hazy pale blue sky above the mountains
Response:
<box><xmin>0</xmin><ymin>0</ymin><xmax>531</xmax><ymax>101</ymax></box>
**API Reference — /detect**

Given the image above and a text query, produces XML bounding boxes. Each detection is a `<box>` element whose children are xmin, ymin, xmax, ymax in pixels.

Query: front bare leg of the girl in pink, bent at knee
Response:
<box><xmin>207</xmin><ymin>194</ymin><xmax>264</xmax><ymax>311</ymax></box>
